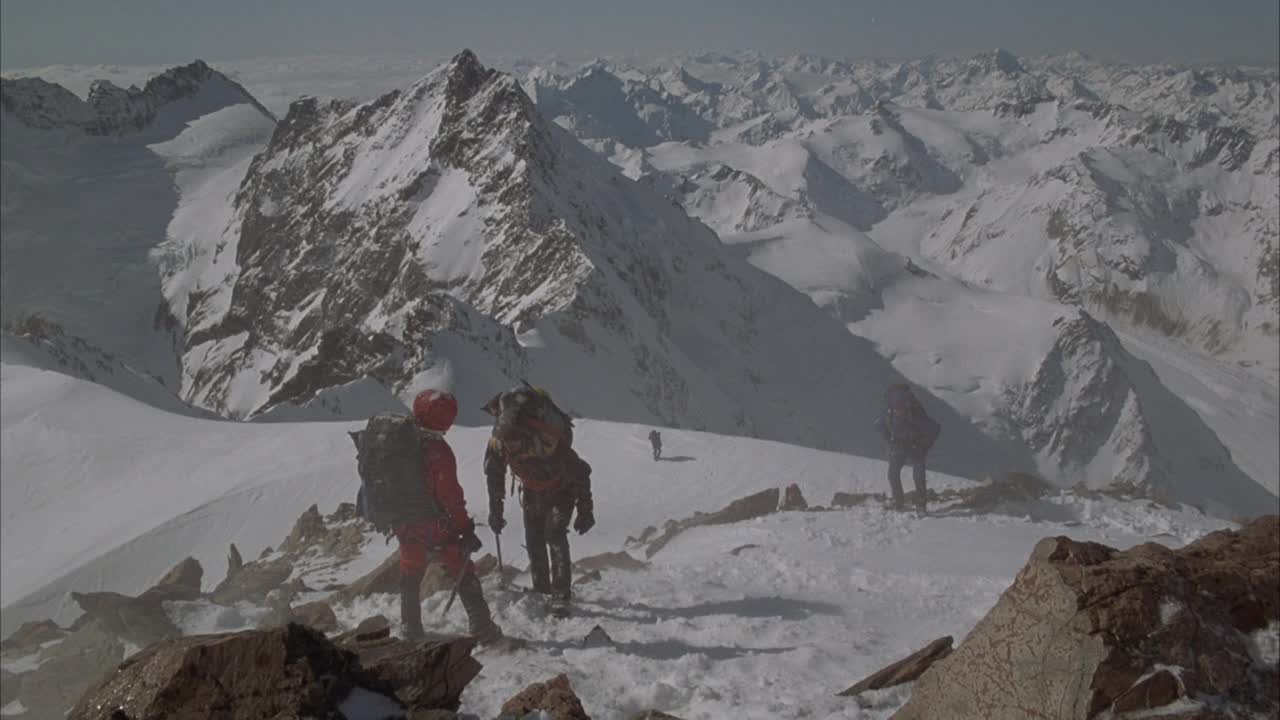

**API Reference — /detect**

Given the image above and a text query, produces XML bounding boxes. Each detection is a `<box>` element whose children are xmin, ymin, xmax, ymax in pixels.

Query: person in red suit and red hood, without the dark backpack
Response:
<box><xmin>353</xmin><ymin>389</ymin><xmax>503</xmax><ymax>644</ymax></box>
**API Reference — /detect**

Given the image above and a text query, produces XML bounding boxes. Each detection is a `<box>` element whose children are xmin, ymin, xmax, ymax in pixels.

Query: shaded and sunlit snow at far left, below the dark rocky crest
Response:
<box><xmin>0</xmin><ymin>68</ymin><xmax>274</xmax><ymax>391</ymax></box>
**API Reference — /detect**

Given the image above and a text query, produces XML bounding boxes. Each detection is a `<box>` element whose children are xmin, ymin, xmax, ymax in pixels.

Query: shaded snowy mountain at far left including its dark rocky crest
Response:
<box><xmin>0</xmin><ymin>63</ymin><xmax>274</xmax><ymax>391</ymax></box>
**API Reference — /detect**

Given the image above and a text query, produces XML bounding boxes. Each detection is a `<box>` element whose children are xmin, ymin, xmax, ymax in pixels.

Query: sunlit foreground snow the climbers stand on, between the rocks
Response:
<box><xmin>0</xmin><ymin>348</ymin><xmax>1228</xmax><ymax>719</ymax></box>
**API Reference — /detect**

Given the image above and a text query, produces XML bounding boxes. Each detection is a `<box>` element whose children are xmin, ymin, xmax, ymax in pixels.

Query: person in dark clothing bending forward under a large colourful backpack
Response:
<box><xmin>484</xmin><ymin>383</ymin><xmax>595</xmax><ymax>615</ymax></box>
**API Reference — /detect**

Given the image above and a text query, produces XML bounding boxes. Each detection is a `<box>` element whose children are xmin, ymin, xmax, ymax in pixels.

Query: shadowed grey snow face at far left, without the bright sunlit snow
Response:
<box><xmin>0</xmin><ymin>111</ymin><xmax>184</xmax><ymax>387</ymax></box>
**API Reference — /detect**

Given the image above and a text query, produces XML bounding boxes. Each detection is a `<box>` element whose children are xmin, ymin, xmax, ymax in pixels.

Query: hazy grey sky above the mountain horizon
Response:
<box><xmin>0</xmin><ymin>0</ymin><xmax>1280</xmax><ymax>68</ymax></box>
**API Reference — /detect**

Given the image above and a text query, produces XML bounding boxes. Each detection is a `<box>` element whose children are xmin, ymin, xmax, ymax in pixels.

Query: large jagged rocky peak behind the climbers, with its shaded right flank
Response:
<box><xmin>162</xmin><ymin>54</ymin><xmax>1029</xmax><ymax>476</ymax></box>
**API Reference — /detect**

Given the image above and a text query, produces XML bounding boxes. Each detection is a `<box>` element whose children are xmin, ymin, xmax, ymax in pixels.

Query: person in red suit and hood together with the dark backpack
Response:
<box><xmin>351</xmin><ymin>389</ymin><xmax>503</xmax><ymax>644</ymax></box>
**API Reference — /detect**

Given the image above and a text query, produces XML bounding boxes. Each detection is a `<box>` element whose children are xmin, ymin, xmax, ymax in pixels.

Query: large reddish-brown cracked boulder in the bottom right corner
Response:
<box><xmin>893</xmin><ymin>515</ymin><xmax>1280</xmax><ymax>720</ymax></box>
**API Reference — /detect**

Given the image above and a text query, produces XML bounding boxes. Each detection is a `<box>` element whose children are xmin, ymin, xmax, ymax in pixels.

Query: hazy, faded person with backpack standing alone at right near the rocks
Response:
<box><xmin>876</xmin><ymin>383</ymin><xmax>942</xmax><ymax>514</ymax></box>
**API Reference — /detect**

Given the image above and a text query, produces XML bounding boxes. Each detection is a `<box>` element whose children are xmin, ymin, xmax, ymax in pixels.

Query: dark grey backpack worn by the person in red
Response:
<box><xmin>349</xmin><ymin>413</ymin><xmax>444</xmax><ymax>533</ymax></box>
